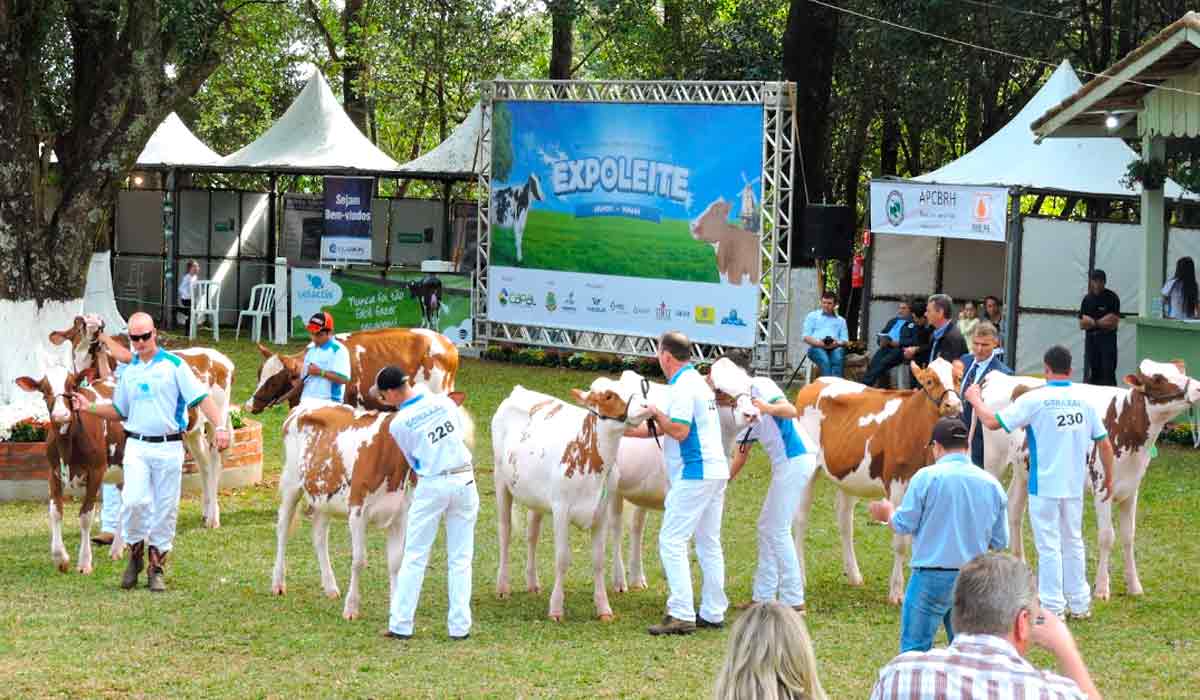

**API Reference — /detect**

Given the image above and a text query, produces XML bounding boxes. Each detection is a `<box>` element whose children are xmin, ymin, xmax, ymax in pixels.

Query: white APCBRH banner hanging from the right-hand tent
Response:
<box><xmin>871</xmin><ymin>180</ymin><xmax>1008</xmax><ymax>243</ymax></box>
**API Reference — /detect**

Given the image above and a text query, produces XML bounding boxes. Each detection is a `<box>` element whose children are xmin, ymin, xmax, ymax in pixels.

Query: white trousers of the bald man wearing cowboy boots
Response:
<box><xmin>121</xmin><ymin>438</ymin><xmax>184</xmax><ymax>552</ymax></box>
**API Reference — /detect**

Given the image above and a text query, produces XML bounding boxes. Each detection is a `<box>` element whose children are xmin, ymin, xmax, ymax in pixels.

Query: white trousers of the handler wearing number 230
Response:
<box><xmin>1030</xmin><ymin>495</ymin><xmax>1092</xmax><ymax>615</ymax></box>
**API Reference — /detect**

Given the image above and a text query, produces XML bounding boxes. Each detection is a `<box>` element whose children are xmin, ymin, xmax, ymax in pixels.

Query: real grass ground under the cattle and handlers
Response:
<box><xmin>0</xmin><ymin>341</ymin><xmax>1200</xmax><ymax>699</ymax></box>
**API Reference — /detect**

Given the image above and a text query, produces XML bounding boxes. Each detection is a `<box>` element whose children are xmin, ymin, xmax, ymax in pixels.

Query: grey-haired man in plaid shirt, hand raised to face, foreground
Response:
<box><xmin>871</xmin><ymin>552</ymin><xmax>1100</xmax><ymax>700</ymax></box>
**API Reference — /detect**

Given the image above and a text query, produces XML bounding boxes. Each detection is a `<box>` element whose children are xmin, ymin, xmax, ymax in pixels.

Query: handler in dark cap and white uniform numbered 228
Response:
<box><xmin>376</xmin><ymin>366</ymin><xmax>479</xmax><ymax>640</ymax></box>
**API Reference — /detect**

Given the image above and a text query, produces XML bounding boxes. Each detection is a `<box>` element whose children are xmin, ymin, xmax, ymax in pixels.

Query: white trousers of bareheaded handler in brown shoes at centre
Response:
<box><xmin>659</xmin><ymin>479</ymin><xmax>730</xmax><ymax>622</ymax></box>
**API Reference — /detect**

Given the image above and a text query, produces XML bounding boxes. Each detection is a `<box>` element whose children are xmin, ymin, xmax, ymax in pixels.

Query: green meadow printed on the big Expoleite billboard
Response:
<box><xmin>492</xmin><ymin>211</ymin><xmax>721</xmax><ymax>283</ymax></box>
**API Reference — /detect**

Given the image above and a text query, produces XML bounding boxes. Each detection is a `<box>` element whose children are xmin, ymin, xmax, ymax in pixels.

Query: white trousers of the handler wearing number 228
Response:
<box><xmin>388</xmin><ymin>472</ymin><xmax>479</xmax><ymax>636</ymax></box>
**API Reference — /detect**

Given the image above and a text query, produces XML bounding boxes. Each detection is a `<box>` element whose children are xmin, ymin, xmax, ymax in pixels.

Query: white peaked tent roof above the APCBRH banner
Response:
<box><xmin>913</xmin><ymin>60</ymin><xmax>1183</xmax><ymax>199</ymax></box>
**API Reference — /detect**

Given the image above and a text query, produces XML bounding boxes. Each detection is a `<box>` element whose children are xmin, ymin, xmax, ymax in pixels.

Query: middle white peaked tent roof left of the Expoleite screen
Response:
<box><xmin>218</xmin><ymin>71</ymin><xmax>397</xmax><ymax>174</ymax></box>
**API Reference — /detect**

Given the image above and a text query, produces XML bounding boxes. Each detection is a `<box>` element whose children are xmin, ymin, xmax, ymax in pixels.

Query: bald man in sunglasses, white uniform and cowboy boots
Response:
<box><xmin>71</xmin><ymin>312</ymin><xmax>229</xmax><ymax>592</ymax></box>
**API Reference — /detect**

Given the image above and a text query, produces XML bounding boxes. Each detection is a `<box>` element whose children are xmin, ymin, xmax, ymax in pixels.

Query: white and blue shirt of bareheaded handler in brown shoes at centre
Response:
<box><xmin>662</xmin><ymin>364</ymin><xmax>730</xmax><ymax>481</ymax></box>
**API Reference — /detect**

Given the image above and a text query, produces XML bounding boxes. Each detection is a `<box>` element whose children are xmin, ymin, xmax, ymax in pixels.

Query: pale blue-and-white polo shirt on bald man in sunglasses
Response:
<box><xmin>113</xmin><ymin>348</ymin><xmax>209</xmax><ymax>437</ymax></box>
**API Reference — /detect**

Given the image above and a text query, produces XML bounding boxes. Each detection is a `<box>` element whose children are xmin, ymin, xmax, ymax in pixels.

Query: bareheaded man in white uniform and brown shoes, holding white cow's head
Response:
<box><xmin>625</xmin><ymin>331</ymin><xmax>730</xmax><ymax>635</ymax></box>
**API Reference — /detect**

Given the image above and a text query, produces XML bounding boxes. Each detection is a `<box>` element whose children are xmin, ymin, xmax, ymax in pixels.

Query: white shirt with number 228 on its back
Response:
<box><xmin>388</xmin><ymin>391</ymin><xmax>470</xmax><ymax>477</ymax></box>
